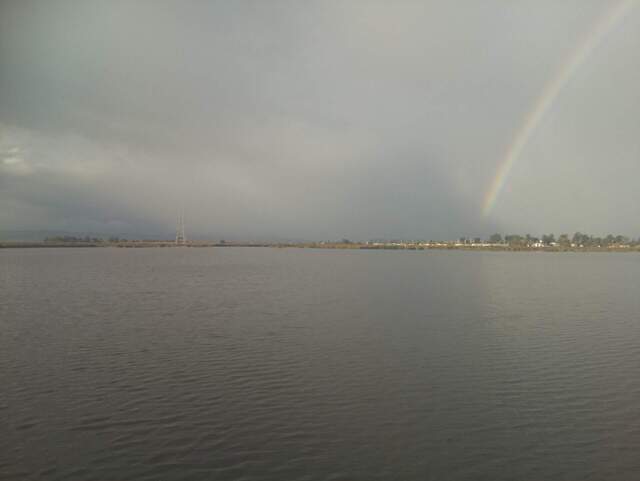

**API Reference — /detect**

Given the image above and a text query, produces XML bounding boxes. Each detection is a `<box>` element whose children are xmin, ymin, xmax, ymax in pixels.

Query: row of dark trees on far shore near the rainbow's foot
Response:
<box><xmin>488</xmin><ymin>232</ymin><xmax>640</xmax><ymax>248</ymax></box>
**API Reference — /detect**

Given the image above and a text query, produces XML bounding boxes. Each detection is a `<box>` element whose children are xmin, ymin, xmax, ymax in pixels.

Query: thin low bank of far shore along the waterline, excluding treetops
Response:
<box><xmin>0</xmin><ymin>240</ymin><xmax>640</xmax><ymax>252</ymax></box>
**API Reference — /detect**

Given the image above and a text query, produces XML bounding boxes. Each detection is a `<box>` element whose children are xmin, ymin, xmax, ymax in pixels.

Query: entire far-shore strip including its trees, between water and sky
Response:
<box><xmin>0</xmin><ymin>232</ymin><xmax>640</xmax><ymax>252</ymax></box>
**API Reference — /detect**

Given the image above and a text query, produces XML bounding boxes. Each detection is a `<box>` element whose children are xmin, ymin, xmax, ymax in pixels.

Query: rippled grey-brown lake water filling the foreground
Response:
<box><xmin>0</xmin><ymin>248</ymin><xmax>640</xmax><ymax>481</ymax></box>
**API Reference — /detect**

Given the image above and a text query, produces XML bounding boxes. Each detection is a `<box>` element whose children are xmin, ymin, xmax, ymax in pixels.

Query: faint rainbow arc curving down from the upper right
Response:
<box><xmin>482</xmin><ymin>0</ymin><xmax>636</xmax><ymax>217</ymax></box>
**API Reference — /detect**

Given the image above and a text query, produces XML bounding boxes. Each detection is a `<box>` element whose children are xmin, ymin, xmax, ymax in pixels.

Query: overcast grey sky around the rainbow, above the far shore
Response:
<box><xmin>0</xmin><ymin>0</ymin><xmax>640</xmax><ymax>239</ymax></box>
